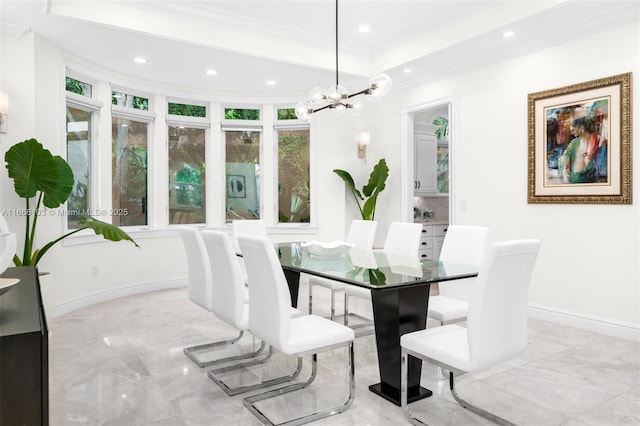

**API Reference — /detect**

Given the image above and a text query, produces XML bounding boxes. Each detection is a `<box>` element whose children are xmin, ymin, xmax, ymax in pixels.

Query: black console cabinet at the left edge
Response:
<box><xmin>0</xmin><ymin>266</ymin><xmax>49</xmax><ymax>426</ymax></box>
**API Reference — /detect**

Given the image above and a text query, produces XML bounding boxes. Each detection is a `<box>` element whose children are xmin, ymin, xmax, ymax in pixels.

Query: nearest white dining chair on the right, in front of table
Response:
<box><xmin>400</xmin><ymin>239</ymin><xmax>540</xmax><ymax>425</ymax></box>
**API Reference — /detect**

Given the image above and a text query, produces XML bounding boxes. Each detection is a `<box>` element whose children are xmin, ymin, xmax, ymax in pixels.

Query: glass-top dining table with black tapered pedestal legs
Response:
<box><xmin>275</xmin><ymin>243</ymin><xmax>478</xmax><ymax>406</ymax></box>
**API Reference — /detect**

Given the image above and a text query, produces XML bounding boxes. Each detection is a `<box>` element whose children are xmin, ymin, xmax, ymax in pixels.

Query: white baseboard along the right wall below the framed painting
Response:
<box><xmin>528</xmin><ymin>304</ymin><xmax>640</xmax><ymax>342</ymax></box>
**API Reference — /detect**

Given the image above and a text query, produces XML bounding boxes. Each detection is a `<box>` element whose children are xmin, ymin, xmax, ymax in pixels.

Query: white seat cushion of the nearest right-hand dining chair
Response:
<box><xmin>400</xmin><ymin>325</ymin><xmax>472</xmax><ymax>372</ymax></box>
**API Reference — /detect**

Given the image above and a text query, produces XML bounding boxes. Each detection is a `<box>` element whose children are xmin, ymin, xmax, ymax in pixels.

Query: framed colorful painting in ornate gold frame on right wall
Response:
<box><xmin>527</xmin><ymin>73</ymin><xmax>632</xmax><ymax>204</ymax></box>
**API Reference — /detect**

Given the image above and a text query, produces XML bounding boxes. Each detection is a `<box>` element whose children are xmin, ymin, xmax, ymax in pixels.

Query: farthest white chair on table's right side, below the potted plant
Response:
<box><xmin>309</xmin><ymin>219</ymin><xmax>378</xmax><ymax>320</ymax></box>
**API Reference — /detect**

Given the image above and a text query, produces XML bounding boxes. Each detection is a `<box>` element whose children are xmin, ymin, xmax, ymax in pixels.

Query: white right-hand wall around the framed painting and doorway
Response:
<box><xmin>376</xmin><ymin>23</ymin><xmax>640</xmax><ymax>338</ymax></box>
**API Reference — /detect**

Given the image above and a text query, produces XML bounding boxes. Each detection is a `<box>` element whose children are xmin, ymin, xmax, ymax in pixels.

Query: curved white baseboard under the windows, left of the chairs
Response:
<box><xmin>53</xmin><ymin>279</ymin><xmax>187</xmax><ymax>318</ymax></box>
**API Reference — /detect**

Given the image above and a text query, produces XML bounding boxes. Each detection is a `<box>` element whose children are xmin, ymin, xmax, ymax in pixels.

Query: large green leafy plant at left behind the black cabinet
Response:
<box><xmin>4</xmin><ymin>139</ymin><xmax>139</xmax><ymax>266</ymax></box>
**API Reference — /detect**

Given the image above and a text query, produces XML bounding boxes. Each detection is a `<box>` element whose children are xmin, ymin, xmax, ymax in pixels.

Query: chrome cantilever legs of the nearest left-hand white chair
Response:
<box><xmin>243</xmin><ymin>342</ymin><xmax>356</xmax><ymax>426</ymax></box>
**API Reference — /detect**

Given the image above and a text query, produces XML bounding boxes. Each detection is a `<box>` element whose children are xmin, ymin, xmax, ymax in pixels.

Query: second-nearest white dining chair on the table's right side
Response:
<box><xmin>427</xmin><ymin>225</ymin><xmax>489</xmax><ymax>325</ymax></box>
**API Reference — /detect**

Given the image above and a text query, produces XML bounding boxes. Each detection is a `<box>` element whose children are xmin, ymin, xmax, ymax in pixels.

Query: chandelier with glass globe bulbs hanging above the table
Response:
<box><xmin>295</xmin><ymin>0</ymin><xmax>391</xmax><ymax>121</ymax></box>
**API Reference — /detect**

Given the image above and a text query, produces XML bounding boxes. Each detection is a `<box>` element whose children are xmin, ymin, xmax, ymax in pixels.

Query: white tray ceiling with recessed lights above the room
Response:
<box><xmin>0</xmin><ymin>0</ymin><xmax>640</xmax><ymax>98</ymax></box>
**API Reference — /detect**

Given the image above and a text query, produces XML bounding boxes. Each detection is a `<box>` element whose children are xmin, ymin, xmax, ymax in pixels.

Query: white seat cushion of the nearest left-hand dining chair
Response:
<box><xmin>284</xmin><ymin>315</ymin><xmax>355</xmax><ymax>355</ymax></box>
